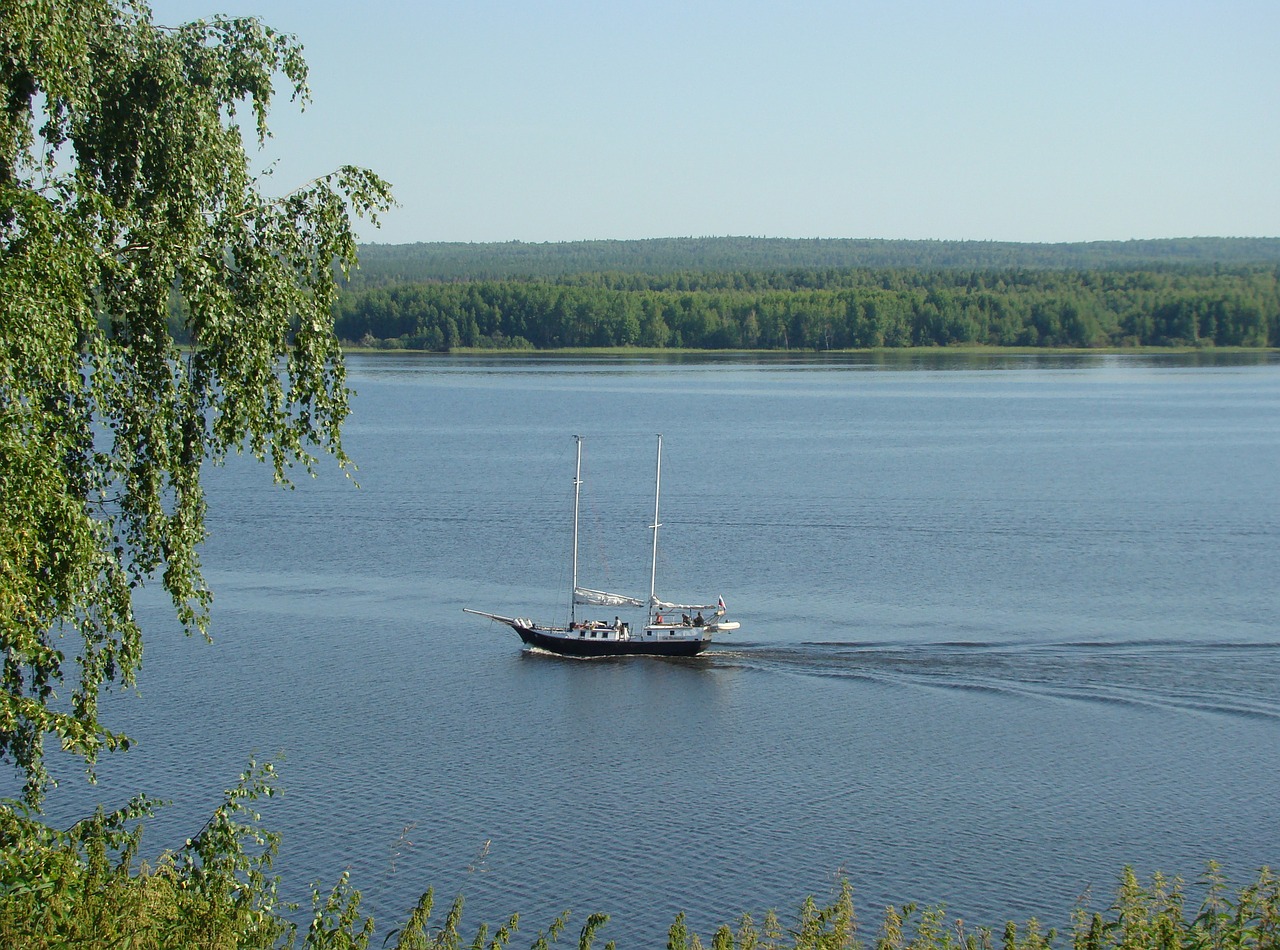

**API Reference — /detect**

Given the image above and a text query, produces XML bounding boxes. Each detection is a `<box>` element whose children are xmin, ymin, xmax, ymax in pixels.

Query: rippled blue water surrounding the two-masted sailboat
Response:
<box><xmin>24</xmin><ymin>355</ymin><xmax>1280</xmax><ymax>947</ymax></box>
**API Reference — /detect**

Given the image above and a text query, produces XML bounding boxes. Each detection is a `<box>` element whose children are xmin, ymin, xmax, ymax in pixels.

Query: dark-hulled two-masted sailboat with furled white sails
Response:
<box><xmin>463</xmin><ymin>435</ymin><xmax>739</xmax><ymax>657</ymax></box>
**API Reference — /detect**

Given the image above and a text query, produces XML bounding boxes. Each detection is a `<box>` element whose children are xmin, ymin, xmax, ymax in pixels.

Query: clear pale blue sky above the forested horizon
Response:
<box><xmin>152</xmin><ymin>0</ymin><xmax>1280</xmax><ymax>243</ymax></box>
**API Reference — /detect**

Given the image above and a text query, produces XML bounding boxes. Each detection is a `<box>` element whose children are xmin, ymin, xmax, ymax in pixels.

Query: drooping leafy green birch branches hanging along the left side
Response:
<box><xmin>0</xmin><ymin>0</ymin><xmax>390</xmax><ymax>803</ymax></box>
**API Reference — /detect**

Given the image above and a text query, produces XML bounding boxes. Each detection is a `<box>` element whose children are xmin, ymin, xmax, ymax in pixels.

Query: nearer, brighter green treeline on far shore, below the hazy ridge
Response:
<box><xmin>335</xmin><ymin>265</ymin><xmax>1280</xmax><ymax>352</ymax></box>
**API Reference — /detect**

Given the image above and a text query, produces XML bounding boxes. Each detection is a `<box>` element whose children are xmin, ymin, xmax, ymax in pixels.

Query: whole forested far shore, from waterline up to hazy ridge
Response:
<box><xmin>337</xmin><ymin>238</ymin><xmax>1280</xmax><ymax>352</ymax></box>
